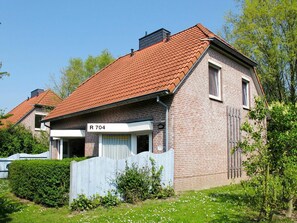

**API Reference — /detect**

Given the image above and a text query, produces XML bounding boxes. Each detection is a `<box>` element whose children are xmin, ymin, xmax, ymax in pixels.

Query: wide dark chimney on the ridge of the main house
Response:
<box><xmin>139</xmin><ymin>28</ymin><xmax>170</xmax><ymax>50</ymax></box>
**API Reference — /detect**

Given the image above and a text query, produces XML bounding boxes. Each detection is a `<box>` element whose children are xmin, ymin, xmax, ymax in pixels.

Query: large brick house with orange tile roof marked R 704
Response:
<box><xmin>45</xmin><ymin>24</ymin><xmax>263</xmax><ymax>190</ymax></box>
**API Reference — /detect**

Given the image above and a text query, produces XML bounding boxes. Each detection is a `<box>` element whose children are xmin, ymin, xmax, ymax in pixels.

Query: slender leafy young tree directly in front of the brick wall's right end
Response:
<box><xmin>237</xmin><ymin>98</ymin><xmax>280</xmax><ymax>220</ymax></box>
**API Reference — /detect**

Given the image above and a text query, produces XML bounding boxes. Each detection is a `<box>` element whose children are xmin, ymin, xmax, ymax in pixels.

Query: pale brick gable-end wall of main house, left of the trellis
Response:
<box><xmin>170</xmin><ymin>49</ymin><xmax>257</xmax><ymax>190</ymax></box>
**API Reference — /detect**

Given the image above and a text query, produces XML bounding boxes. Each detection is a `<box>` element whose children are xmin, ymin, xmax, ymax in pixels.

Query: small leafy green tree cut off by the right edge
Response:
<box><xmin>268</xmin><ymin>103</ymin><xmax>297</xmax><ymax>217</ymax></box>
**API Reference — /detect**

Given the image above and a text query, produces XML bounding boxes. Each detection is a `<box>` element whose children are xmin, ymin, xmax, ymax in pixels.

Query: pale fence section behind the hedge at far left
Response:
<box><xmin>0</xmin><ymin>151</ymin><xmax>49</xmax><ymax>178</ymax></box>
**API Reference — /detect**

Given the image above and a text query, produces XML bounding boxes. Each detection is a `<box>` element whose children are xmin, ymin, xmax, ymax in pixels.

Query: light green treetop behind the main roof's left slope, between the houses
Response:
<box><xmin>51</xmin><ymin>50</ymin><xmax>114</xmax><ymax>98</ymax></box>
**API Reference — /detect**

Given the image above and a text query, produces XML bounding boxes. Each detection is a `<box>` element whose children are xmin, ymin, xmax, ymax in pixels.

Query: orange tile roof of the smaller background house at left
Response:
<box><xmin>2</xmin><ymin>90</ymin><xmax>62</xmax><ymax>126</ymax></box>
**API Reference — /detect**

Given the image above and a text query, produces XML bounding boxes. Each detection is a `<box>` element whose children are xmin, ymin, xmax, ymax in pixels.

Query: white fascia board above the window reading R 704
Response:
<box><xmin>87</xmin><ymin>121</ymin><xmax>153</xmax><ymax>133</ymax></box>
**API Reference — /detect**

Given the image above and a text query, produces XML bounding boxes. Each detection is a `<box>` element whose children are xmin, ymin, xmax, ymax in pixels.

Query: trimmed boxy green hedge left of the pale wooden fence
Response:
<box><xmin>9</xmin><ymin>159</ymin><xmax>82</xmax><ymax>207</ymax></box>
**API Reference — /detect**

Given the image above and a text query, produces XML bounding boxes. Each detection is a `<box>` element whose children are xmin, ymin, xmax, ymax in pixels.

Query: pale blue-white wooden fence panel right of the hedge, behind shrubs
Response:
<box><xmin>69</xmin><ymin>149</ymin><xmax>174</xmax><ymax>203</ymax></box>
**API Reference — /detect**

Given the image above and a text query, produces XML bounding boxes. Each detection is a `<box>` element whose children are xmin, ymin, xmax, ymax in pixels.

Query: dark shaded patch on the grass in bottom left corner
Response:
<box><xmin>0</xmin><ymin>194</ymin><xmax>22</xmax><ymax>222</ymax></box>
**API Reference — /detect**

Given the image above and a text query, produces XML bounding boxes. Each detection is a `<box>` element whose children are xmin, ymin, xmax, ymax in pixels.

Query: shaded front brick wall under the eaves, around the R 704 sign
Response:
<box><xmin>51</xmin><ymin>99</ymin><xmax>168</xmax><ymax>156</ymax></box>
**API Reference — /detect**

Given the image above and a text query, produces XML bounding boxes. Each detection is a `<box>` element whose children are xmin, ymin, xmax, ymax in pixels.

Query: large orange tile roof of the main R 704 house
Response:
<box><xmin>46</xmin><ymin>24</ymin><xmax>254</xmax><ymax>120</ymax></box>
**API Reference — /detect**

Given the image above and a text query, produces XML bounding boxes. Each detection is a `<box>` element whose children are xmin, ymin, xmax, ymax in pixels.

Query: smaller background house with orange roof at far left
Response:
<box><xmin>2</xmin><ymin>89</ymin><xmax>62</xmax><ymax>134</ymax></box>
